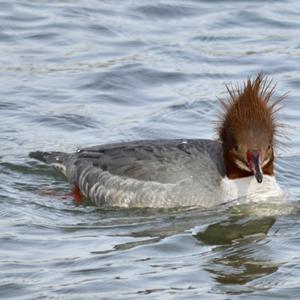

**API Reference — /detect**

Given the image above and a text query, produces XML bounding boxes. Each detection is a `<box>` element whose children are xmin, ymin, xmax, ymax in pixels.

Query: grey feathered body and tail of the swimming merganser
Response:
<box><xmin>30</xmin><ymin>139</ymin><xmax>225</xmax><ymax>208</ymax></box>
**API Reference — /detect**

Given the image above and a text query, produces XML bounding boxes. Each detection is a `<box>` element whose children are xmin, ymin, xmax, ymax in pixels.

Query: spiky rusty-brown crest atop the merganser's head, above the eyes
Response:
<box><xmin>218</xmin><ymin>73</ymin><xmax>285</xmax><ymax>143</ymax></box>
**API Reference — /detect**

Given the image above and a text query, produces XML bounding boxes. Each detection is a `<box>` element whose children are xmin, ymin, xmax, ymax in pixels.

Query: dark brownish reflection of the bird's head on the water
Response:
<box><xmin>194</xmin><ymin>216</ymin><xmax>279</xmax><ymax>285</ymax></box>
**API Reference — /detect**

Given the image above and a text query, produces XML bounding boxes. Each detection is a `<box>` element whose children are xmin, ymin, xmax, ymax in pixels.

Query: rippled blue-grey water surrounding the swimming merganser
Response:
<box><xmin>0</xmin><ymin>0</ymin><xmax>300</xmax><ymax>299</ymax></box>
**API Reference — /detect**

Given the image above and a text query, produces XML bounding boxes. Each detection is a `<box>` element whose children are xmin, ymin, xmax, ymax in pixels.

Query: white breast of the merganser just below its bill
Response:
<box><xmin>221</xmin><ymin>175</ymin><xmax>283</xmax><ymax>202</ymax></box>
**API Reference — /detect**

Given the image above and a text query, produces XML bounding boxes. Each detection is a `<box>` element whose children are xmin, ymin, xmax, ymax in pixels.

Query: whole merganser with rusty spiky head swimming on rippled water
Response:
<box><xmin>29</xmin><ymin>74</ymin><xmax>283</xmax><ymax>208</ymax></box>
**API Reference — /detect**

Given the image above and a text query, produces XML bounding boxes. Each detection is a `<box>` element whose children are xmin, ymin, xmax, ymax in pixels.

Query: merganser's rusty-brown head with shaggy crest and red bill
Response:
<box><xmin>218</xmin><ymin>74</ymin><xmax>284</xmax><ymax>183</ymax></box>
